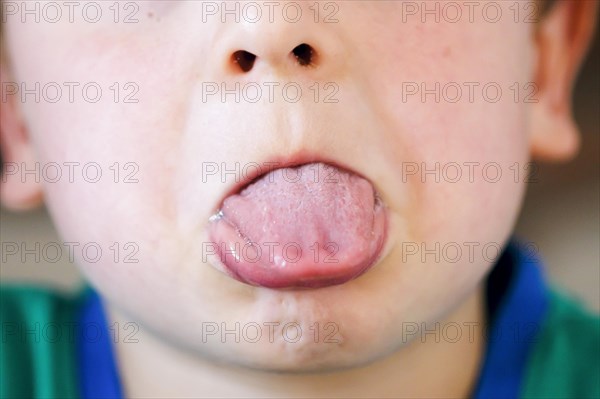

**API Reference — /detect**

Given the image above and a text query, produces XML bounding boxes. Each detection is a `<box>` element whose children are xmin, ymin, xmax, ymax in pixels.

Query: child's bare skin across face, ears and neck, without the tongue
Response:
<box><xmin>0</xmin><ymin>1</ymin><xmax>596</xmax><ymax>397</ymax></box>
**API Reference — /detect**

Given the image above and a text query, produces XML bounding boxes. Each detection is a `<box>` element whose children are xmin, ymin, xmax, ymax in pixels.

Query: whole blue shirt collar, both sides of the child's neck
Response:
<box><xmin>78</xmin><ymin>239</ymin><xmax>547</xmax><ymax>399</ymax></box>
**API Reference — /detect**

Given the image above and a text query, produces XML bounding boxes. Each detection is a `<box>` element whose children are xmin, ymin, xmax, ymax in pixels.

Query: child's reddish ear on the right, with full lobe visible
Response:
<box><xmin>530</xmin><ymin>0</ymin><xmax>598</xmax><ymax>161</ymax></box>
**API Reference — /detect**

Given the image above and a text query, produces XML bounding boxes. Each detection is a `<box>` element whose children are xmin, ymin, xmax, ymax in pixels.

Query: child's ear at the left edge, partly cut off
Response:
<box><xmin>0</xmin><ymin>62</ymin><xmax>42</xmax><ymax>211</ymax></box>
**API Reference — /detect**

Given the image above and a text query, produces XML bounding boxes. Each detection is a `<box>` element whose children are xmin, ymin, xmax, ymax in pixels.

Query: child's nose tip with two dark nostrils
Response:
<box><xmin>211</xmin><ymin>2</ymin><xmax>344</xmax><ymax>75</ymax></box>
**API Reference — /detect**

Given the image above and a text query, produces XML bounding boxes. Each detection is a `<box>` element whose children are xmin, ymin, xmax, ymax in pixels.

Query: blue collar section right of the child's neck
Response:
<box><xmin>473</xmin><ymin>242</ymin><xmax>548</xmax><ymax>399</ymax></box>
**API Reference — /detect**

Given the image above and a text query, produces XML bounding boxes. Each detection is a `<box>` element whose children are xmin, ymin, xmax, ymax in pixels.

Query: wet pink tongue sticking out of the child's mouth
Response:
<box><xmin>211</xmin><ymin>163</ymin><xmax>386</xmax><ymax>288</ymax></box>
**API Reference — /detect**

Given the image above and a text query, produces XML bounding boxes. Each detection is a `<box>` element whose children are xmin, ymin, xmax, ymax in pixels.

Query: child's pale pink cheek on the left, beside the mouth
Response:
<box><xmin>6</xmin><ymin>25</ymin><xmax>197</xmax><ymax>292</ymax></box>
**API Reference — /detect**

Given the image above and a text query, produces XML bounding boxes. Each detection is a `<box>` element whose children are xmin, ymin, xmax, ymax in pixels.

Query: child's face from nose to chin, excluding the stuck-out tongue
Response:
<box><xmin>4</xmin><ymin>1</ymin><xmax>592</xmax><ymax>370</ymax></box>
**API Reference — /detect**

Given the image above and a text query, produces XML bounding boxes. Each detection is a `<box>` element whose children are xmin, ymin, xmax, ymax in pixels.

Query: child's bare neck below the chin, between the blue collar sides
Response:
<box><xmin>108</xmin><ymin>289</ymin><xmax>484</xmax><ymax>398</ymax></box>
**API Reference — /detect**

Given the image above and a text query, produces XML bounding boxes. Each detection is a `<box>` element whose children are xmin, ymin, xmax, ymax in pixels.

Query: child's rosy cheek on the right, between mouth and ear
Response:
<box><xmin>366</xmin><ymin>14</ymin><xmax>532</xmax><ymax>244</ymax></box>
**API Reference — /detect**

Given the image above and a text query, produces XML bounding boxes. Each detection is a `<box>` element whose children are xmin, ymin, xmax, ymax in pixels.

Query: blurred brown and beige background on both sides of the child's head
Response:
<box><xmin>0</xmin><ymin>12</ymin><xmax>600</xmax><ymax>311</ymax></box>
